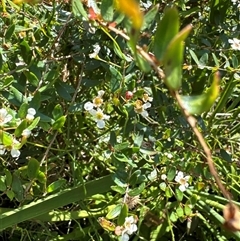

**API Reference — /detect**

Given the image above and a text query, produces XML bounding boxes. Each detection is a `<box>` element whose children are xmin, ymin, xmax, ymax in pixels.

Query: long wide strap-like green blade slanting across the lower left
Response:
<box><xmin>0</xmin><ymin>175</ymin><xmax>113</xmax><ymax>231</ymax></box>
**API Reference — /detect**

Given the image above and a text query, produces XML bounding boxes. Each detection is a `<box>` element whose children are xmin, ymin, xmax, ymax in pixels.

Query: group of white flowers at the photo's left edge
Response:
<box><xmin>0</xmin><ymin>108</ymin><xmax>36</xmax><ymax>158</ymax></box>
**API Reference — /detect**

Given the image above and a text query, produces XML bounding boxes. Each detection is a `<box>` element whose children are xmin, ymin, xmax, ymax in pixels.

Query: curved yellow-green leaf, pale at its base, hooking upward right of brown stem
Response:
<box><xmin>180</xmin><ymin>72</ymin><xmax>220</xmax><ymax>115</ymax></box>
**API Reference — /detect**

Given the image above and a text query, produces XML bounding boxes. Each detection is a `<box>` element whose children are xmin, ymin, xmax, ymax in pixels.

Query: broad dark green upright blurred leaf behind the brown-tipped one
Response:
<box><xmin>153</xmin><ymin>7</ymin><xmax>180</xmax><ymax>61</ymax></box>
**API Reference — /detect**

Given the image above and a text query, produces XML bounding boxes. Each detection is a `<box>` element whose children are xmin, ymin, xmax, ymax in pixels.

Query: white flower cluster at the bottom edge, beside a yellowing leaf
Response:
<box><xmin>115</xmin><ymin>216</ymin><xmax>137</xmax><ymax>241</ymax></box>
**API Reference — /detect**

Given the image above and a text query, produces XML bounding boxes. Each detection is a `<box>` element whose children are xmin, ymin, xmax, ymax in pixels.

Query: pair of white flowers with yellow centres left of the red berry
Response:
<box><xmin>84</xmin><ymin>90</ymin><xmax>110</xmax><ymax>129</ymax></box>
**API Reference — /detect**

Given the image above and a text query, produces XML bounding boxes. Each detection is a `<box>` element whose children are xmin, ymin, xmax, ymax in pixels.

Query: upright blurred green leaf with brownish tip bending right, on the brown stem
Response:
<box><xmin>163</xmin><ymin>25</ymin><xmax>192</xmax><ymax>90</ymax></box>
